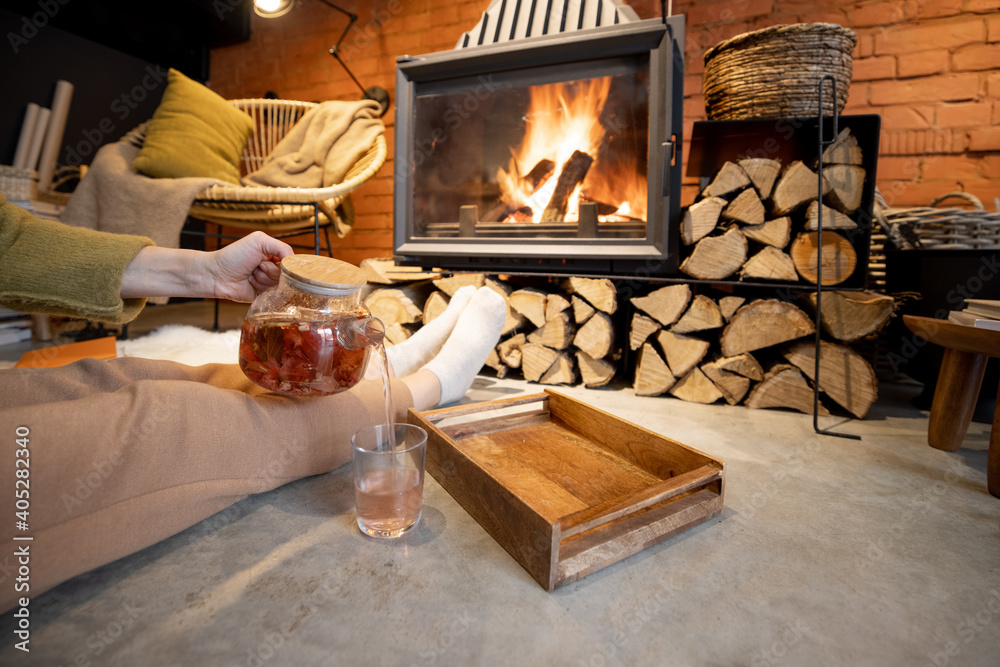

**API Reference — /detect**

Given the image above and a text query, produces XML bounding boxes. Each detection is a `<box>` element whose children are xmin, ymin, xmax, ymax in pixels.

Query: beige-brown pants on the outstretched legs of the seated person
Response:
<box><xmin>0</xmin><ymin>358</ymin><xmax>413</xmax><ymax>612</ymax></box>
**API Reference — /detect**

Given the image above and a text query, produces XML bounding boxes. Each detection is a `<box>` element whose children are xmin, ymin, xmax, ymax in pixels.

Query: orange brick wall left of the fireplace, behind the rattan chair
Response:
<box><xmin>211</xmin><ymin>0</ymin><xmax>489</xmax><ymax>264</ymax></box>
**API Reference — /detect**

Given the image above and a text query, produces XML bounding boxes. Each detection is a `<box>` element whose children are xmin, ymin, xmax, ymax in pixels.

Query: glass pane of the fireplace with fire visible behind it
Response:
<box><xmin>413</xmin><ymin>60</ymin><xmax>649</xmax><ymax>239</ymax></box>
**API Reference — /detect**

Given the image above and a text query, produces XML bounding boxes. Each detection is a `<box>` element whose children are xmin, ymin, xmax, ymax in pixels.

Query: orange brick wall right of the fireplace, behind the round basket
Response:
<box><xmin>629</xmin><ymin>0</ymin><xmax>1000</xmax><ymax>210</ymax></box>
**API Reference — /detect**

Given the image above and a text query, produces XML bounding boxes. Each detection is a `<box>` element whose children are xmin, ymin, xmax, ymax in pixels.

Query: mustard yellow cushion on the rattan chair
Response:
<box><xmin>132</xmin><ymin>69</ymin><xmax>253</xmax><ymax>184</ymax></box>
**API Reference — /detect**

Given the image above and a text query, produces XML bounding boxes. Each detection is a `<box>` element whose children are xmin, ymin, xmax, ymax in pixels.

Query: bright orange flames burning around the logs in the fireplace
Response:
<box><xmin>497</xmin><ymin>77</ymin><xmax>646</xmax><ymax>223</ymax></box>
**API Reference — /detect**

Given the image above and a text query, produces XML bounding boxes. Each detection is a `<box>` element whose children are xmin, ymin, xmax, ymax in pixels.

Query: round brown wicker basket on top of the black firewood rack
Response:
<box><xmin>704</xmin><ymin>23</ymin><xmax>858</xmax><ymax>120</ymax></box>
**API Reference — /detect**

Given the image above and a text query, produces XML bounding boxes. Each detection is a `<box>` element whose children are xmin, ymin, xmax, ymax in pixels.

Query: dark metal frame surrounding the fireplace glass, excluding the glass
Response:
<box><xmin>393</xmin><ymin>16</ymin><xmax>684</xmax><ymax>276</ymax></box>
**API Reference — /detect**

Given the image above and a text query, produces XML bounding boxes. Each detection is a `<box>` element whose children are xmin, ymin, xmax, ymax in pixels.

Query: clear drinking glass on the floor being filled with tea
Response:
<box><xmin>351</xmin><ymin>424</ymin><xmax>427</xmax><ymax>537</ymax></box>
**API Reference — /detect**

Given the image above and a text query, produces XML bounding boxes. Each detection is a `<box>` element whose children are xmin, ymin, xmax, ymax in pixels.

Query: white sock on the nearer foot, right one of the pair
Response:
<box><xmin>424</xmin><ymin>287</ymin><xmax>507</xmax><ymax>405</ymax></box>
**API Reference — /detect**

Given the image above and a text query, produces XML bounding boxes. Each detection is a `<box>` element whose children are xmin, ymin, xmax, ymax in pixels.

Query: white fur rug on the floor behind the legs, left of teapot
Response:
<box><xmin>117</xmin><ymin>324</ymin><xmax>240</xmax><ymax>366</ymax></box>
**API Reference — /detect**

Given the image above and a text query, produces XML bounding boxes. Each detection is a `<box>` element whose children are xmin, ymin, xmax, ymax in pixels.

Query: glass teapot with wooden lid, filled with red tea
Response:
<box><xmin>239</xmin><ymin>255</ymin><xmax>385</xmax><ymax>396</ymax></box>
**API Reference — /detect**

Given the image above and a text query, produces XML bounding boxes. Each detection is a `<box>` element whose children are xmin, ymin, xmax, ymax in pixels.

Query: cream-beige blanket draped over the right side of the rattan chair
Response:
<box><xmin>243</xmin><ymin>100</ymin><xmax>385</xmax><ymax>188</ymax></box>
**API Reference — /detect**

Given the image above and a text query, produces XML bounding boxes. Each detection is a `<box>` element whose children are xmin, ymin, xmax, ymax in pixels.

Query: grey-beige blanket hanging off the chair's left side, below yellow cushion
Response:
<box><xmin>59</xmin><ymin>141</ymin><xmax>227</xmax><ymax>248</ymax></box>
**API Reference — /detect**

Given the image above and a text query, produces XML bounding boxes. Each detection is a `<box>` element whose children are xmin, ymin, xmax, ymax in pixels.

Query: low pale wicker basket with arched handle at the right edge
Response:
<box><xmin>885</xmin><ymin>192</ymin><xmax>1000</xmax><ymax>250</ymax></box>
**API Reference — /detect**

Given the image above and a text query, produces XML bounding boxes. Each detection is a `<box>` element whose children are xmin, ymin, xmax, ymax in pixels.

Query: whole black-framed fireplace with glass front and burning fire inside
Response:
<box><xmin>394</xmin><ymin>17</ymin><xmax>684</xmax><ymax>275</ymax></box>
